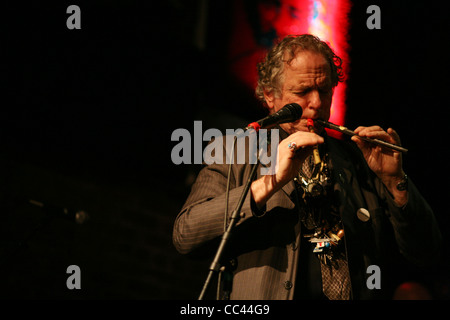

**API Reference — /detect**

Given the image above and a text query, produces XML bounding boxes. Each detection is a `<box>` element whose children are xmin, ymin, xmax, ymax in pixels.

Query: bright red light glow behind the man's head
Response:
<box><xmin>229</xmin><ymin>0</ymin><xmax>350</xmax><ymax>125</ymax></box>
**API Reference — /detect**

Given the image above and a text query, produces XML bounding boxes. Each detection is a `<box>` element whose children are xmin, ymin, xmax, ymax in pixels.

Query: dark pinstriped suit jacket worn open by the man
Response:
<box><xmin>173</xmin><ymin>130</ymin><xmax>441</xmax><ymax>300</ymax></box>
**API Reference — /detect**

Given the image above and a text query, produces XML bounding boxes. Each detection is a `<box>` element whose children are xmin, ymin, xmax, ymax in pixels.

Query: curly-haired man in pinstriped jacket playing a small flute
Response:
<box><xmin>173</xmin><ymin>35</ymin><xmax>441</xmax><ymax>299</ymax></box>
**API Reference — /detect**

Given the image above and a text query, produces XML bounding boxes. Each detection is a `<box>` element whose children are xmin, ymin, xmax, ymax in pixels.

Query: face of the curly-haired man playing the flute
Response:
<box><xmin>264</xmin><ymin>51</ymin><xmax>333</xmax><ymax>134</ymax></box>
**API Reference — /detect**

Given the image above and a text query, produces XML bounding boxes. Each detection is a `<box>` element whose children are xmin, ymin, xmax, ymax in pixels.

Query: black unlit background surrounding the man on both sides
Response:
<box><xmin>0</xmin><ymin>0</ymin><xmax>450</xmax><ymax>299</ymax></box>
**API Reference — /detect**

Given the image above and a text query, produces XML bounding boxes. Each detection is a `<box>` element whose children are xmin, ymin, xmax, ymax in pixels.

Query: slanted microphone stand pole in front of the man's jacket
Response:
<box><xmin>198</xmin><ymin>157</ymin><xmax>259</xmax><ymax>300</ymax></box>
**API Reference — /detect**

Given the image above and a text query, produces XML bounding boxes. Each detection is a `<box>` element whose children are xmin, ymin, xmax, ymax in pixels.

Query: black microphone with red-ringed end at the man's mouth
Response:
<box><xmin>245</xmin><ymin>103</ymin><xmax>303</xmax><ymax>131</ymax></box>
